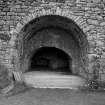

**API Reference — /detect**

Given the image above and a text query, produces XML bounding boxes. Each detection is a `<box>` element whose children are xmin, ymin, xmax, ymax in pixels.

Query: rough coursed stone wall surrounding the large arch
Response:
<box><xmin>0</xmin><ymin>0</ymin><xmax>105</xmax><ymax>80</ymax></box>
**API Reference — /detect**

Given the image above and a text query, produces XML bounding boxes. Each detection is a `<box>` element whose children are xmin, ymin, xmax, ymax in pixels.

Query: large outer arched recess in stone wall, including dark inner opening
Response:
<box><xmin>18</xmin><ymin>15</ymin><xmax>88</xmax><ymax>76</ymax></box>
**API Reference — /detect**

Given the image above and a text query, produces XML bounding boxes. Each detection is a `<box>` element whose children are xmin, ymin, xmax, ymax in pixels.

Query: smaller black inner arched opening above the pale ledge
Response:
<box><xmin>29</xmin><ymin>47</ymin><xmax>72</xmax><ymax>74</ymax></box>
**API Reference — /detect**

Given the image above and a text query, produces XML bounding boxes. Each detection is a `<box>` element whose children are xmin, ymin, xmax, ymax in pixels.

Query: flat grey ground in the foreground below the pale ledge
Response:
<box><xmin>0</xmin><ymin>88</ymin><xmax>105</xmax><ymax>105</ymax></box>
